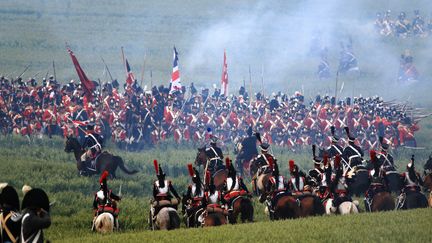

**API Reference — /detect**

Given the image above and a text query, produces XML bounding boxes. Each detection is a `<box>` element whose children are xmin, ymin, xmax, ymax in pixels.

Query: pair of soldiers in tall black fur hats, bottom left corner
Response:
<box><xmin>0</xmin><ymin>183</ymin><xmax>51</xmax><ymax>243</ymax></box>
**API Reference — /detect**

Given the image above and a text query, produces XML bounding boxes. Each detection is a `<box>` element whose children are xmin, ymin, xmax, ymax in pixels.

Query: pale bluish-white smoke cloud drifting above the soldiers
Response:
<box><xmin>185</xmin><ymin>0</ymin><xmax>431</xmax><ymax>103</ymax></box>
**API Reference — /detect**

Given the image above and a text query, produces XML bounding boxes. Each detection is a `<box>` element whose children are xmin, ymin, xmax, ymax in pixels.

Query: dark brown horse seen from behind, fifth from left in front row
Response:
<box><xmin>228</xmin><ymin>196</ymin><xmax>254</xmax><ymax>224</ymax></box>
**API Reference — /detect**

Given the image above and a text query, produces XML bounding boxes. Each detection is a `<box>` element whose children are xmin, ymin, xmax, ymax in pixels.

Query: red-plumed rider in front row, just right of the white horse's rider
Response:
<box><xmin>364</xmin><ymin>150</ymin><xmax>388</xmax><ymax>211</ymax></box>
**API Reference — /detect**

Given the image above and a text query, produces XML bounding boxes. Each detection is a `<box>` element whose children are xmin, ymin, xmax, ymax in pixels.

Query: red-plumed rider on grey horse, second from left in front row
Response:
<box><xmin>150</xmin><ymin>160</ymin><xmax>180</xmax><ymax>220</ymax></box>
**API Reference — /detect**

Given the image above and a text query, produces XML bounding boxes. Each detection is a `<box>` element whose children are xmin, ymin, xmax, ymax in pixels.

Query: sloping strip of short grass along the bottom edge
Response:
<box><xmin>62</xmin><ymin>209</ymin><xmax>432</xmax><ymax>242</ymax></box>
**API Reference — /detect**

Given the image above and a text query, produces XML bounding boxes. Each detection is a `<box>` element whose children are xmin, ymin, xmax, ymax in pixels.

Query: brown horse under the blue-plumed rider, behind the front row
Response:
<box><xmin>195</xmin><ymin>147</ymin><xmax>228</xmax><ymax>190</ymax></box>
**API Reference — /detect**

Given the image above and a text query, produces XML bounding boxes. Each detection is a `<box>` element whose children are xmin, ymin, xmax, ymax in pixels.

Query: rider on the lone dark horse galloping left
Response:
<box><xmin>80</xmin><ymin>123</ymin><xmax>103</xmax><ymax>174</ymax></box>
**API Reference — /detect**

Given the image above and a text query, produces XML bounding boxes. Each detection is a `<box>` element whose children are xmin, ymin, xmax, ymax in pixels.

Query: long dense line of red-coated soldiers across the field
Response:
<box><xmin>0</xmin><ymin>74</ymin><xmax>421</xmax><ymax>151</ymax></box>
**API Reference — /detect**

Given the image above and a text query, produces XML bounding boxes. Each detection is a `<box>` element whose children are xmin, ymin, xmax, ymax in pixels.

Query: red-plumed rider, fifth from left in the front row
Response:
<box><xmin>224</xmin><ymin>157</ymin><xmax>249</xmax><ymax>212</ymax></box>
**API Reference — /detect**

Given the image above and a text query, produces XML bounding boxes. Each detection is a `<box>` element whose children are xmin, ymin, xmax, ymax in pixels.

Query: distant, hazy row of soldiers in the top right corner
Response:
<box><xmin>374</xmin><ymin>10</ymin><xmax>432</xmax><ymax>38</ymax></box>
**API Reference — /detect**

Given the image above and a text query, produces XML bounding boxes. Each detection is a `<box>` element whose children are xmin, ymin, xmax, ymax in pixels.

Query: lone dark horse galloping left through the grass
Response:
<box><xmin>64</xmin><ymin>137</ymin><xmax>138</xmax><ymax>178</ymax></box>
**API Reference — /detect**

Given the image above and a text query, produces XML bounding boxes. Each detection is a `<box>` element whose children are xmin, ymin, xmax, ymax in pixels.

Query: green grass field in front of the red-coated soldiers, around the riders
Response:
<box><xmin>0</xmin><ymin>137</ymin><xmax>432</xmax><ymax>242</ymax></box>
